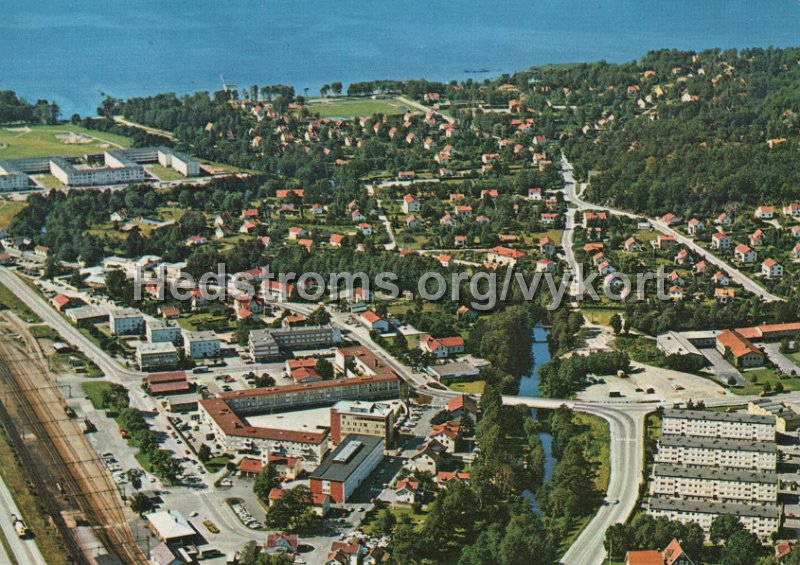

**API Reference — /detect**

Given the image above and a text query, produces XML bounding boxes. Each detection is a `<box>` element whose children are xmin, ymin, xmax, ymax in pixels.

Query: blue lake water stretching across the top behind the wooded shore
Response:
<box><xmin>0</xmin><ymin>0</ymin><xmax>800</xmax><ymax>117</ymax></box>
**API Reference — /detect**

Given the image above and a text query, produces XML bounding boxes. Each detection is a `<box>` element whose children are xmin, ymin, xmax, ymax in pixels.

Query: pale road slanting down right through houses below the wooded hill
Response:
<box><xmin>561</xmin><ymin>155</ymin><xmax>783</xmax><ymax>302</ymax></box>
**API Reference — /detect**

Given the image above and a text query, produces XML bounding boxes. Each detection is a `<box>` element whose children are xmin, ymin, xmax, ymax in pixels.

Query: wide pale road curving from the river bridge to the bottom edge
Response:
<box><xmin>503</xmin><ymin>396</ymin><xmax>658</xmax><ymax>565</ymax></box>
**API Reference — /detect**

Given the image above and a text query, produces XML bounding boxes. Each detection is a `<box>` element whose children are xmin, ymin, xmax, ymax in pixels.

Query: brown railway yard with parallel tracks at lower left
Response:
<box><xmin>0</xmin><ymin>316</ymin><xmax>147</xmax><ymax>563</ymax></box>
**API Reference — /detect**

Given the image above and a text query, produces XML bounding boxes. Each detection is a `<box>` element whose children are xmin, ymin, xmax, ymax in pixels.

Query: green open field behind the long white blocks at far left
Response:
<box><xmin>0</xmin><ymin>124</ymin><xmax>131</xmax><ymax>159</ymax></box>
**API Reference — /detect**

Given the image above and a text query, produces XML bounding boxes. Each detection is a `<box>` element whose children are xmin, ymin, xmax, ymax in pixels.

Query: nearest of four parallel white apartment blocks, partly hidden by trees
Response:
<box><xmin>647</xmin><ymin>497</ymin><xmax>780</xmax><ymax>543</ymax></box>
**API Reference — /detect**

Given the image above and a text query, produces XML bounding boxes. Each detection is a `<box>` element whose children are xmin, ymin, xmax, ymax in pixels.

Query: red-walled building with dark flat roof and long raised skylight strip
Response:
<box><xmin>309</xmin><ymin>434</ymin><xmax>384</xmax><ymax>504</ymax></box>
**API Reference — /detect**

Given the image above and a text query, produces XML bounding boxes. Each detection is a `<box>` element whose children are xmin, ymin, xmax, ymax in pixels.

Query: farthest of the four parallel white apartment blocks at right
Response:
<box><xmin>661</xmin><ymin>409</ymin><xmax>775</xmax><ymax>442</ymax></box>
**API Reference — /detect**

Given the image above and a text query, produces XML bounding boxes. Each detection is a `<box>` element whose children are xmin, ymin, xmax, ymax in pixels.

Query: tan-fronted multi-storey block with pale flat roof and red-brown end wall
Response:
<box><xmin>331</xmin><ymin>400</ymin><xmax>395</xmax><ymax>446</ymax></box>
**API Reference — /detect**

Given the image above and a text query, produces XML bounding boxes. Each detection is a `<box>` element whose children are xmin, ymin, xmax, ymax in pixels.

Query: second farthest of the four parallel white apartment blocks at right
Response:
<box><xmin>656</xmin><ymin>435</ymin><xmax>778</xmax><ymax>471</ymax></box>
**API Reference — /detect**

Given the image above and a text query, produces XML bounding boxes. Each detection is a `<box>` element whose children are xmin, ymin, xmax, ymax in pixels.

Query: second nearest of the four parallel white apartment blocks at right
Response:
<box><xmin>650</xmin><ymin>463</ymin><xmax>778</xmax><ymax>504</ymax></box>
